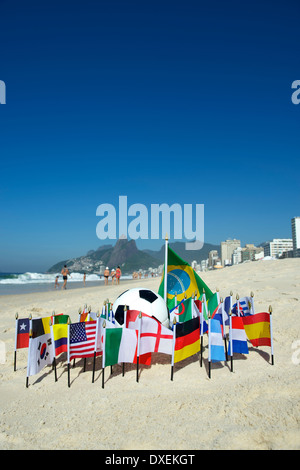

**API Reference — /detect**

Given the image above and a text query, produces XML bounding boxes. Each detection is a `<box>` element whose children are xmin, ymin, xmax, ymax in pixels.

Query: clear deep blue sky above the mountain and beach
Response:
<box><xmin>0</xmin><ymin>0</ymin><xmax>300</xmax><ymax>272</ymax></box>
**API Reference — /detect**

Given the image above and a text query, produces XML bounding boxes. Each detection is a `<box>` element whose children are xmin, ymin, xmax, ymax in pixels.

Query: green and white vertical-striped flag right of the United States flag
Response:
<box><xmin>104</xmin><ymin>328</ymin><xmax>138</xmax><ymax>367</ymax></box>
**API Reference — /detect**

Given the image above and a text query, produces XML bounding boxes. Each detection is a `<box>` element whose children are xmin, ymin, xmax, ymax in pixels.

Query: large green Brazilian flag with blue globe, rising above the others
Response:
<box><xmin>158</xmin><ymin>246</ymin><xmax>213</xmax><ymax>306</ymax></box>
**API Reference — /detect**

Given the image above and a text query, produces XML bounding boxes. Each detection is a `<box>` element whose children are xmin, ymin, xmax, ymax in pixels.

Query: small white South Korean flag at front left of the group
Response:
<box><xmin>27</xmin><ymin>333</ymin><xmax>53</xmax><ymax>377</ymax></box>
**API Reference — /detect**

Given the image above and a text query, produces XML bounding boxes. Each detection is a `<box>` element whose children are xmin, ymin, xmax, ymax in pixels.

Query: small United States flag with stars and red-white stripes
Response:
<box><xmin>69</xmin><ymin>321</ymin><xmax>97</xmax><ymax>361</ymax></box>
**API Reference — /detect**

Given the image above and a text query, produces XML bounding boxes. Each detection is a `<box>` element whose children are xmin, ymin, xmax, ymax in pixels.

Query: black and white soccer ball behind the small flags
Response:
<box><xmin>113</xmin><ymin>287</ymin><xmax>169</xmax><ymax>328</ymax></box>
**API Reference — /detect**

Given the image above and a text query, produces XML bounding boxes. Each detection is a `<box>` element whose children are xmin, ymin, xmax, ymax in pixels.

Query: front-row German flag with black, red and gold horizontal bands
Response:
<box><xmin>174</xmin><ymin>317</ymin><xmax>200</xmax><ymax>363</ymax></box>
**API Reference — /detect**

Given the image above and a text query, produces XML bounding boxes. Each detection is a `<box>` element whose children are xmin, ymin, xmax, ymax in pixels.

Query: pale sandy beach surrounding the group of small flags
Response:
<box><xmin>0</xmin><ymin>259</ymin><xmax>300</xmax><ymax>450</ymax></box>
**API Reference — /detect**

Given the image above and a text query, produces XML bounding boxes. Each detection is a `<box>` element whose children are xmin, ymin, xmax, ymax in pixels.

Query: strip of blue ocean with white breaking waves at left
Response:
<box><xmin>0</xmin><ymin>272</ymin><xmax>132</xmax><ymax>296</ymax></box>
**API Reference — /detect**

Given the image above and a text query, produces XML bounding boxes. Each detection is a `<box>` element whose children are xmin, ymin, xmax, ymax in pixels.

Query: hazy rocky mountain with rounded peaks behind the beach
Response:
<box><xmin>48</xmin><ymin>239</ymin><xmax>220</xmax><ymax>274</ymax></box>
